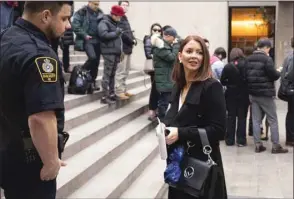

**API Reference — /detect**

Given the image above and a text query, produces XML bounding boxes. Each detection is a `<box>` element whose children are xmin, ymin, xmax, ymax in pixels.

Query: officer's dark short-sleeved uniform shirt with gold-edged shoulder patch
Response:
<box><xmin>0</xmin><ymin>19</ymin><xmax>64</xmax><ymax>145</ymax></box>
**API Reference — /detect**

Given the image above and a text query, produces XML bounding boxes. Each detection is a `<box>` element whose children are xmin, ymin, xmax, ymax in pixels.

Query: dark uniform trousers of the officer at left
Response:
<box><xmin>0</xmin><ymin>146</ymin><xmax>56</xmax><ymax>199</ymax></box>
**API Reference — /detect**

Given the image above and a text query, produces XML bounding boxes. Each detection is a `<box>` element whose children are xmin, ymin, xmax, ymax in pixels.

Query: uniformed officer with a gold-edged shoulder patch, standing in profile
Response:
<box><xmin>0</xmin><ymin>1</ymin><xmax>73</xmax><ymax>199</ymax></box>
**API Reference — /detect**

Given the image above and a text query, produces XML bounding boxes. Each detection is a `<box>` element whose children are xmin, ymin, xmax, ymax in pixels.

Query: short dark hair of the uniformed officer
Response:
<box><xmin>24</xmin><ymin>1</ymin><xmax>73</xmax><ymax>14</ymax></box>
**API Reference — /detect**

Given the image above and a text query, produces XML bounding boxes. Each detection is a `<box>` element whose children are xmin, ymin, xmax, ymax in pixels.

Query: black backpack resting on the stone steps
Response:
<box><xmin>68</xmin><ymin>65</ymin><xmax>92</xmax><ymax>95</ymax></box>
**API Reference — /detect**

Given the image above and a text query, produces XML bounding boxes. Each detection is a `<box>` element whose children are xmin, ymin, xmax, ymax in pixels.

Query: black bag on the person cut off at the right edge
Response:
<box><xmin>278</xmin><ymin>56</ymin><xmax>294</xmax><ymax>102</ymax></box>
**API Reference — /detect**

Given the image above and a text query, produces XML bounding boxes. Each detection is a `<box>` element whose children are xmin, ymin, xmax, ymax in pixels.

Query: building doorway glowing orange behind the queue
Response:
<box><xmin>229</xmin><ymin>6</ymin><xmax>276</xmax><ymax>59</ymax></box>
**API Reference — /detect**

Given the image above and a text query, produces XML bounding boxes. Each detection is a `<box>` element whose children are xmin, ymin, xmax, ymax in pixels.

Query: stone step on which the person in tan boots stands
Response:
<box><xmin>65</xmin><ymin>86</ymin><xmax>149</xmax><ymax>131</ymax></box>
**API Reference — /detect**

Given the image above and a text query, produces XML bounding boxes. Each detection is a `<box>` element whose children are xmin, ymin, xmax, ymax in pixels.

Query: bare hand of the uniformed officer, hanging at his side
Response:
<box><xmin>40</xmin><ymin>159</ymin><xmax>66</xmax><ymax>181</ymax></box>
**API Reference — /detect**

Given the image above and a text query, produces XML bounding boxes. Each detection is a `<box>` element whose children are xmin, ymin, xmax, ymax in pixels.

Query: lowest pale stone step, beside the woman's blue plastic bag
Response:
<box><xmin>120</xmin><ymin>155</ymin><xmax>166</xmax><ymax>199</ymax></box>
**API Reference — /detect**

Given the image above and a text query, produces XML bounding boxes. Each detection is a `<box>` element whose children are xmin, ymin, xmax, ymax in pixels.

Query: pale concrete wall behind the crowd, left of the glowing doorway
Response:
<box><xmin>75</xmin><ymin>1</ymin><xmax>228</xmax><ymax>69</ymax></box>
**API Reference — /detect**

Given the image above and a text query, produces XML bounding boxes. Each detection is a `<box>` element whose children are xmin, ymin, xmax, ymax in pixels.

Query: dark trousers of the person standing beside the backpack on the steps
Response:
<box><xmin>84</xmin><ymin>40</ymin><xmax>101</xmax><ymax>82</ymax></box>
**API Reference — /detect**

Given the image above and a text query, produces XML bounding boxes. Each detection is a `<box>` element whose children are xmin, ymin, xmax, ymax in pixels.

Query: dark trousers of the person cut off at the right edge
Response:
<box><xmin>286</xmin><ymin>97</ymin><xmax>294</xmax><ymax>142</ymax></box>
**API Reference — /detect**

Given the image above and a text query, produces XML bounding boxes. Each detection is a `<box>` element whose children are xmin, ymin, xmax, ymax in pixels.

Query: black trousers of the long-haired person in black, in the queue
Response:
<box><xmin>225</xmin><ymin>91</ymin><xmax>249</xmax><ymax>145</ymax></box>
